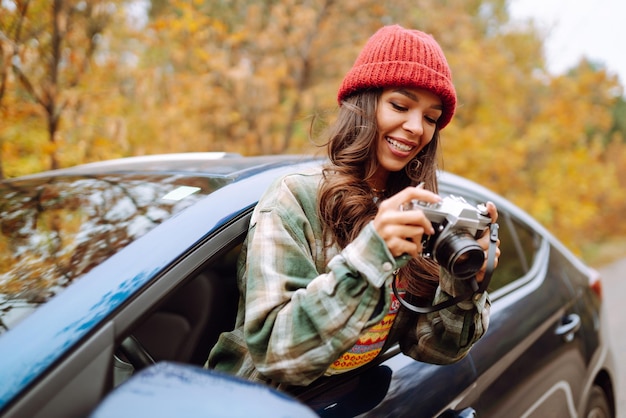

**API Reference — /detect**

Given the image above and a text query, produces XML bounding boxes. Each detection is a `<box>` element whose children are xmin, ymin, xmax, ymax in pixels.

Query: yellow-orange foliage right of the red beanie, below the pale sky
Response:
<box><xmin>432</xmin><ymin>3</ymin><xmax>626</xmax><ymax>251</ymax></box>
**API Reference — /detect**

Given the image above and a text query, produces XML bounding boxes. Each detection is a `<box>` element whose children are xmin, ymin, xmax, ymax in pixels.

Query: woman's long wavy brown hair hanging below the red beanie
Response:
<box><xmin>318</xmin><ymin>89</ymin><xmax>439</xmax><ymax>299</ymax></box>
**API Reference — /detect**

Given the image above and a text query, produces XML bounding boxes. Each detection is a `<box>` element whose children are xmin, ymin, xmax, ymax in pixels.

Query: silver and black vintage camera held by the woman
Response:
<box><xmin>401</xmin><ymin>195</ymin><xmax>491</xmax><ymax>280</ymax></box>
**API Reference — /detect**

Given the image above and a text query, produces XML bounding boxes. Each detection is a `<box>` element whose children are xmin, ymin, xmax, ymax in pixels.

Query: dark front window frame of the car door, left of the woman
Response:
<box><xmin>2</xmin><ymin>205</ymin><xmax>255</xmax><ymax>417</ymax></box>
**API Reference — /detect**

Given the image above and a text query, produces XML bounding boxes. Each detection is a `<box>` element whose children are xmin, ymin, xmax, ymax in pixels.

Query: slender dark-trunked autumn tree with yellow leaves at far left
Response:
<box><xmin>5</xmin><ymin>0</ymin><xmax>116</xmax><ymax>169</ymax></box>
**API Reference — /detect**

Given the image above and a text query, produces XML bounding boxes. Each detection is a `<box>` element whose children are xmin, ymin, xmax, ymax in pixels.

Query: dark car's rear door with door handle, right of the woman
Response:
<box><xmin>458</xmin><ymin>209</ymin><xmax>586</xmax><ymax>417</ymax></box>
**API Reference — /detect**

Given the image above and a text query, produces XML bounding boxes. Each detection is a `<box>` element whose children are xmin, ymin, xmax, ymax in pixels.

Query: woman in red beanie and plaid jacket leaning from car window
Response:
<box><xmin>208</xmin><ymin>25</ymin><xmax>499</xmax><ymax>389</ymax></box>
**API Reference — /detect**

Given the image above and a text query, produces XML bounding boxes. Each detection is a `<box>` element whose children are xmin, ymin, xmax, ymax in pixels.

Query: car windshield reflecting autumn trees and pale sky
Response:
<box><xmin>0</xmin><ymin>175</ymin><xmax>226</xmax><ymax>334</ymax></box>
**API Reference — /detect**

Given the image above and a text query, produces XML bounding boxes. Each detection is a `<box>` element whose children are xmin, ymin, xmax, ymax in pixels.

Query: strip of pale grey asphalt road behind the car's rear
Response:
<box><xmin>598</xmin><ymin>258</ymin><xmax>626</xmax><ymax>418</ymax></box>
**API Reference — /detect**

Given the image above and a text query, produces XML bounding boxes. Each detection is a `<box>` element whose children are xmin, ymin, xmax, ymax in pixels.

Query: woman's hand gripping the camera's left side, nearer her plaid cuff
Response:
<box><xmin>374</xmin><ymin>186</ymin><xmax>438</xmax><ymax>257</ymax></box>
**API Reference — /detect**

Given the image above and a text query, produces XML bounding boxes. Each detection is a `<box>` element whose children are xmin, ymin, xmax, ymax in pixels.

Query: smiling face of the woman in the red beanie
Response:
<box><xmin>370</xmin><ymin>88</ymin><xmax>442</xmax><ymax>188</ymax></box>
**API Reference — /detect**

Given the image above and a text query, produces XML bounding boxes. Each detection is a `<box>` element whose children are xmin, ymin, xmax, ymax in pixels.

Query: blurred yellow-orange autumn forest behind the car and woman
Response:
<box><xmin>0</xmin><ymin>0</ymin><xmax>626</xmax><ymax>258</ymax></box>
